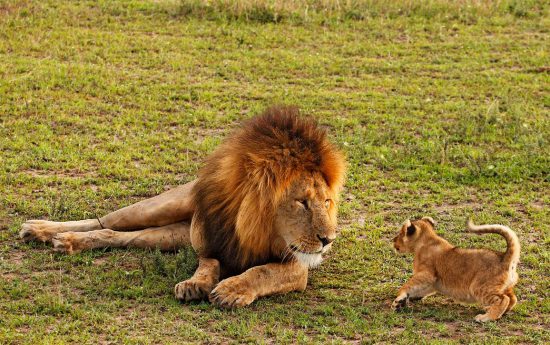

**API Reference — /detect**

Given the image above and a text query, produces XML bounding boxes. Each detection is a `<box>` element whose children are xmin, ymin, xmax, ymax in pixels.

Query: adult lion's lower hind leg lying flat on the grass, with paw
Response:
<box><xmin>52</xmin><ymin>222</ymin><xmax>191</xmax><ymax>254</ymax></box>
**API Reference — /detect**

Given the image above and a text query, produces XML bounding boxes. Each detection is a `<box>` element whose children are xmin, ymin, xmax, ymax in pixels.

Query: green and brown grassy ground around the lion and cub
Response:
<box><xmin>0</xmin><ymin>0</ymin><xmax>550</xmax><ymax>344</ymax></box>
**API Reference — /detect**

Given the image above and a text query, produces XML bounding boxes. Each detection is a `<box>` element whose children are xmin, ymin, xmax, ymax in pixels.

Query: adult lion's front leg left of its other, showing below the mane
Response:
<box><xmin>174</xmin><ymin>257</ymin><xmax>220</xmax><ymax>302</ymax></box>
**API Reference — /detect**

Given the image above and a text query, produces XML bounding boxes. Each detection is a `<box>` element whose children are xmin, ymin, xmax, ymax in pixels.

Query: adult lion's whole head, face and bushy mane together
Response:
<box><xmin>194</xmin><ymin>107</ymin><xmax>345</xmax><ymax>271</ymax></box>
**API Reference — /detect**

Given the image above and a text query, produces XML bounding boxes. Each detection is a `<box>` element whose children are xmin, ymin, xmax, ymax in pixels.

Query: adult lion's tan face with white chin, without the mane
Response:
<box><xmin>274</xmin><ymin>174</ymin><xmax>336</xmax><ymax>267</ymax></box>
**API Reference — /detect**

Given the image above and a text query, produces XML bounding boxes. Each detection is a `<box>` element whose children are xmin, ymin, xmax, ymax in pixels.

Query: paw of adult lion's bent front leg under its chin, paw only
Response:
<box><xmin>209</xmin><ymin>277</ymin><xmax>256</xmax><ymax>308</ymax></box>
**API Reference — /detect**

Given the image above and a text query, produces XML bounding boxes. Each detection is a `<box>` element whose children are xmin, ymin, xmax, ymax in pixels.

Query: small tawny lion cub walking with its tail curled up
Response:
<box><xmin>392</xmin><ymin>217</ymin><xmax>520</xmax><ymax>322</ymax></box>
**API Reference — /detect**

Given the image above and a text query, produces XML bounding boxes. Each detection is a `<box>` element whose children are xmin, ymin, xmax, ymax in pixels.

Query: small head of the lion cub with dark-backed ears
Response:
<box><xmin>393</xmin><ymin>217</ymin><xmax>435</xmax><ymax>253</ymax></box>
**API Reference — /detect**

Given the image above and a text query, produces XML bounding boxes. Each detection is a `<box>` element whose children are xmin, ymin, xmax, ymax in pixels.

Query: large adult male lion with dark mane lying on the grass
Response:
<box><xmin>20</xmin><ymin>107</ymin><xmax>345</xmax><ymax>307</ymax></box>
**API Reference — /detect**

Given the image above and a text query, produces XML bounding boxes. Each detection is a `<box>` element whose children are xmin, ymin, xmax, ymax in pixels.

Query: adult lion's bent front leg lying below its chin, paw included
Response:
<box><xmin>209</xmin><ymin>262</ymin><xmax>308</xmax><ymax>308</ymax></box>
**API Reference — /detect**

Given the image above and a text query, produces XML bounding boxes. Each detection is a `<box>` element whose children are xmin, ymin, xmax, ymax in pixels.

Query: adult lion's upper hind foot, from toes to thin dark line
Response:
<box><xmin>19</xmin><ymin>219</ymin><xmax>101</xmax><ymax>242</ymax></box>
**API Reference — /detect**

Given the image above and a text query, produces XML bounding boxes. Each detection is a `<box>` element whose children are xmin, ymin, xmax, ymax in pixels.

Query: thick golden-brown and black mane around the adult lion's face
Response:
<box><xmin>193</xmin><ymin>106</ymin><xmax>345</xmax><ymax>273</ymax></box>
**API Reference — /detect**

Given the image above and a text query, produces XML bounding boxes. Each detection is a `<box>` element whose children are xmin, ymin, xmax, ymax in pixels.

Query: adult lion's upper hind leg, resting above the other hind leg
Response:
<box><xmin>19</xmin><ymin>181</ymin><xmax>195</xmax><ymax>242</ymax></box>
